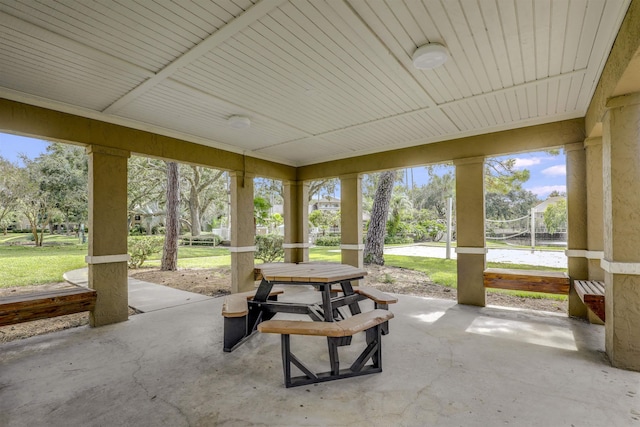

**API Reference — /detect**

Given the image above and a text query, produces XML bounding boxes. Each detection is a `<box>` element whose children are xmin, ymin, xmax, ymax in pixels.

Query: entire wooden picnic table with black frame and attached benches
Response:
<box><xmin>223</xmin><ymin>263</ymin><xmax>397</xmax><ymax>387</ymax></box>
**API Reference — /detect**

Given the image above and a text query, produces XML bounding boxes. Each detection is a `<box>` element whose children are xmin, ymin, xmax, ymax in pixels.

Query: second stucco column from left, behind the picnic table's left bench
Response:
<box><xmin>229</xmin><ymin>171</ymin><xmax>256</xmax><ymax>293</ymax></box>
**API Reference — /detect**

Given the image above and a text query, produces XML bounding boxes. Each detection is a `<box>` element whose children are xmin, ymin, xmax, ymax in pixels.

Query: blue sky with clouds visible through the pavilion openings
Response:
<box><xmin>0</xmin><ymin>133</ymin><xmax>567</xmax><ymax>200</ymax></box>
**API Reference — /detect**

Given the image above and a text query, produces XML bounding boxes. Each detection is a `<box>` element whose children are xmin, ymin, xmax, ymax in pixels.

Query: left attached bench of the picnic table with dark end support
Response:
<box><xmin>222</xmin><ymin>288</ymin><xmax>284</xmax><ymax>352</ymax></box>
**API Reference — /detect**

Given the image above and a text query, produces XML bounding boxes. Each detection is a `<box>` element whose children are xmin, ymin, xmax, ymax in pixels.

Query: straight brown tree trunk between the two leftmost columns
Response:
<box><xmin>160</xmin><ymin>162</ymin><xmax>180</xmax><ymax>271</ymax></box>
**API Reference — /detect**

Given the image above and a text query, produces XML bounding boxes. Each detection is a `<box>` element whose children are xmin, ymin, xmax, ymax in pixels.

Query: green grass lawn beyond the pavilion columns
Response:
<box><xmin>0</xmin><ymin>239</ymin><xmax>566</xmax><ymax>300</ymax></box>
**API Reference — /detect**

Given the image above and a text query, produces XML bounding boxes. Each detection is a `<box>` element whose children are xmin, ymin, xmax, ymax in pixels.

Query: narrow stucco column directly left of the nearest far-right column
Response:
<box><xmin>584</xmin><ymin>137</ymin><xmax>604</xmax><ymax>280</ymax></box>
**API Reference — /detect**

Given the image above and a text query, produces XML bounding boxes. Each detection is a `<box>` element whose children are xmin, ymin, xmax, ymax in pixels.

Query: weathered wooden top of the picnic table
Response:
<box><xmin>255</xmin><ymin>262</ymin><xmax>367</xmax><ymax>283</ymax></box>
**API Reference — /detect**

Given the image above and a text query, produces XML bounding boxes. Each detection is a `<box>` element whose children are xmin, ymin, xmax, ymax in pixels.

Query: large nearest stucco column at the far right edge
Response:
<box><xmin>602</xmin><ymin>92</ymin><xmax>640</xmax><ymax>371</ymax></box>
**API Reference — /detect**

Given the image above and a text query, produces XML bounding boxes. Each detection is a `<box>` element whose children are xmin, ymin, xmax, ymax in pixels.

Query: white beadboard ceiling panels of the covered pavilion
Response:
<box><xmin>0</xmin><ymin>0</ymin><xmax>630</xmax><ymax>166</ymax></box>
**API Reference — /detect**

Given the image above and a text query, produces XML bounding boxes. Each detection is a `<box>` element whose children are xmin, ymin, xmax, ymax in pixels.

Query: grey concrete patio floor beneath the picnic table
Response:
<box><xmin>0</xmin><ymin>287</ymin><xmax>640</xmax><ymax>427</ymax></box>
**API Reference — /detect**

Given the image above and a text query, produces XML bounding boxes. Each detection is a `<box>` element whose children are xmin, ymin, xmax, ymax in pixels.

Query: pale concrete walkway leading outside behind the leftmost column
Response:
<box><xmin>63</xmin><ymin>268</ymin><xmax>213</xmax><ymax>313</ymax></box>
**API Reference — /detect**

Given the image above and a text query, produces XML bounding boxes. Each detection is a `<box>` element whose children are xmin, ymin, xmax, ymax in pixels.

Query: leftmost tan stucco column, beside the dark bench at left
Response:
<box><xmin>86</xmin><ymin>145</ymin><xmax>130</xmax><ymax>326</ymax></box>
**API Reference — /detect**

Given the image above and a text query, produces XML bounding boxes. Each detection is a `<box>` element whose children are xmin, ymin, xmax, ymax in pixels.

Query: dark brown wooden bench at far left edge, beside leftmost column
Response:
<box><xmin>0</xmin><ymin>286</ymin><xmax>97</xmax><ymax>326</ymax></box>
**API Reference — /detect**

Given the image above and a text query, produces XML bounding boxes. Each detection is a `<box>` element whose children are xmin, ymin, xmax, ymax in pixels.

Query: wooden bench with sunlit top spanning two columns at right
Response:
<box><xmin>483</xmin><ymin>268</ymin><xmax>570</xmax><ymax>295</ymax></box>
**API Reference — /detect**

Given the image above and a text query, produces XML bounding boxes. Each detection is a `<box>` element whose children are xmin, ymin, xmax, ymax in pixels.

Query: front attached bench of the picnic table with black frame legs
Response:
<box><xmin>258</xmin><ymin>309</ymin><xmax>393</xmax><ymax>388</ymax></box>
